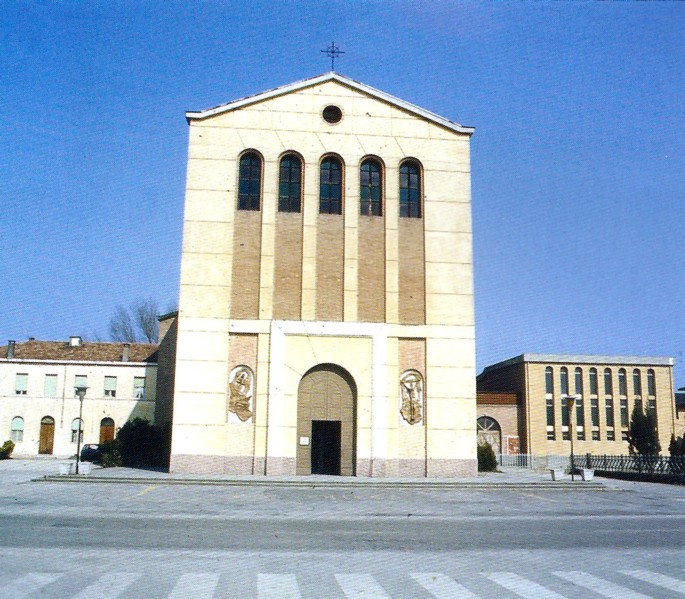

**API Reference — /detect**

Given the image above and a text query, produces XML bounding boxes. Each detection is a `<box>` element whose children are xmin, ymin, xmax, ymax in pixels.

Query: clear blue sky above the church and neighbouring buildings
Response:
<box><xmin>0</xmin><ymin>0</ymin><xmax>685</xmax><ymax>386</ymax></box>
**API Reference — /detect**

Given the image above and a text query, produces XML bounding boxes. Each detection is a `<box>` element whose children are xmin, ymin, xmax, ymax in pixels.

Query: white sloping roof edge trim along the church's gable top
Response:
<box><xmin>186</xmin><ymin>71</ymin><xmax>474</xmax><ymax>135</ymax></box>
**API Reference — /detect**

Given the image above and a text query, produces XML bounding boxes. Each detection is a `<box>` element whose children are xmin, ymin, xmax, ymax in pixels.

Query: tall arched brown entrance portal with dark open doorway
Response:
<box><xmin>297</xmin><ymin>364</ymin><xmax>357</xmax><ymax>476</ymax></box>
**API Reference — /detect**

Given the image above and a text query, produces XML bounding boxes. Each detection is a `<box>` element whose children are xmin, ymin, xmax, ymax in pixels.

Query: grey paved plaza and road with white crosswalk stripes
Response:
<box><xmin>0</xmin><ymin>459</ymin><xmax>685</xmax><ymax>599</ymax></box>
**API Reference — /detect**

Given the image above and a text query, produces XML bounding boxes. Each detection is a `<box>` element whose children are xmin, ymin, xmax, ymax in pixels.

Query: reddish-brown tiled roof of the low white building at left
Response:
<box><xmin>0</xmin><ymin>340</ymin><xmax>157</xmax><ymax>363</ymax></box>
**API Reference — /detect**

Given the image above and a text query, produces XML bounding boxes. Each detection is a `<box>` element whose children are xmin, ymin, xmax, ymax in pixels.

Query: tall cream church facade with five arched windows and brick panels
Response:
<box><xmin>168</xmin><ymin>72</ymin><xmax>476</xmax><ymax>477</ymax></box>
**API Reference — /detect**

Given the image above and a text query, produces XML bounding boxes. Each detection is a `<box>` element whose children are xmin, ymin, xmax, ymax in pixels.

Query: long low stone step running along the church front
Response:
<box><xmin>31</xmin><ymin>475</ymin><xmax>609</xmax><ymax>491</ymax></box>
